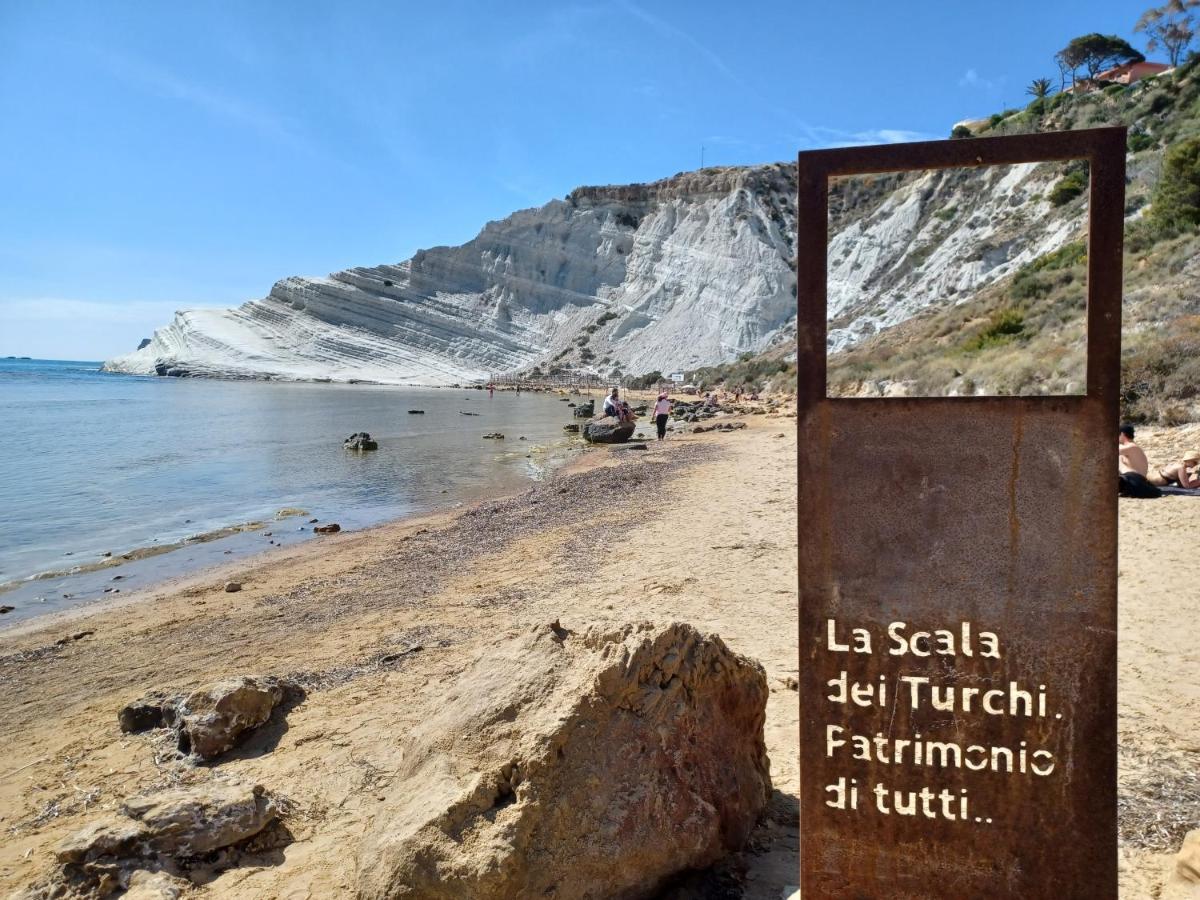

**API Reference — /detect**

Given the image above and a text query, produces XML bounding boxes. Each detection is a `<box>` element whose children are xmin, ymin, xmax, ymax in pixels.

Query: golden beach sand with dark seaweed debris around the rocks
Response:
<box><xmin>0</xmin><ymin>415</ymin><xmax>1200</xmax><ymax>900</ymax></box>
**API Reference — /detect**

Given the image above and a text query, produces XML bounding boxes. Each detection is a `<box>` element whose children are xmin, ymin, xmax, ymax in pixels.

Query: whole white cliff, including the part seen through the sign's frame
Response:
<box><xmin>104</xmin><ymin>163</ymin><xmax>1080</xmax><ymax>384</ymax></box>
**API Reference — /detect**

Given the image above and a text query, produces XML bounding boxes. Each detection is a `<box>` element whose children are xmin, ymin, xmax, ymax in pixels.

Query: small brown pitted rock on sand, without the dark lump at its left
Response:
<box><xmin>167</xmin><ymin>676</ymin><xmax>288</xmax><ymax>760</ymax></box>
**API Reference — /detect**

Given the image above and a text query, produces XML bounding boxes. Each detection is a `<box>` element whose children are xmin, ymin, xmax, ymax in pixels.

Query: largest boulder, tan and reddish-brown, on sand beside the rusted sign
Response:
<box><xmin>358</xmin><ymin>623</ymin><xmax>770</xmax><ymax>900</ymax></box>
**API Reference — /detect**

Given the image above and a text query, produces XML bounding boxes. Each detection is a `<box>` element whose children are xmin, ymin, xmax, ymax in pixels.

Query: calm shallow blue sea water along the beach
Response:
<box><xmin>0</xmin><ymin>359</ymin><xmax>577</xmax><ymax>628</ymax></box>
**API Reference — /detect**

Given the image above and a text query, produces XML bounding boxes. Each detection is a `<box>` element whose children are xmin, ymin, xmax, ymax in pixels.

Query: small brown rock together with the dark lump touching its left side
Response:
<box><xmin>118</xmin><ymin>676</ymin><xmax>299</xmax><ymax>760</ymax></box>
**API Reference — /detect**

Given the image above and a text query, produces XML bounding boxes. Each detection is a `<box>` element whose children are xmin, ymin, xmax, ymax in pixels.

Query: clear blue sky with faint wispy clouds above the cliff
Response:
<box><xmin>0</xmin><ymin>0</ymin><xmax>1154</xmax><ymax>360</ymax></box>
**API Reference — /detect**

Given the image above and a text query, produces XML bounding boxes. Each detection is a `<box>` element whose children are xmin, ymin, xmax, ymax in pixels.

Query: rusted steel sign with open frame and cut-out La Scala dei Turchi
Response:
<box><xmin>797</xmin><ymin>128</ymin><xmax>1126</xmax><ymax>900</ymax></box>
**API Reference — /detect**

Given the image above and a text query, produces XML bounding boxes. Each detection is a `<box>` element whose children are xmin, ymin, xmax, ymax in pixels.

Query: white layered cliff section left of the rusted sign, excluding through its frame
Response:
<box><xmin>106</xmin><ymin>164</ymin><xmax>794</xmax><ymax>384</ymax></box>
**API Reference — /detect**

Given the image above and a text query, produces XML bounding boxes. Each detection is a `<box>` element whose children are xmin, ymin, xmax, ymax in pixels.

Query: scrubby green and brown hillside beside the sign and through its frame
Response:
<box><xmin>811</xmin><ymin>59</ymin><xmax>1200</xmax><ymax>424</ymax></box>
